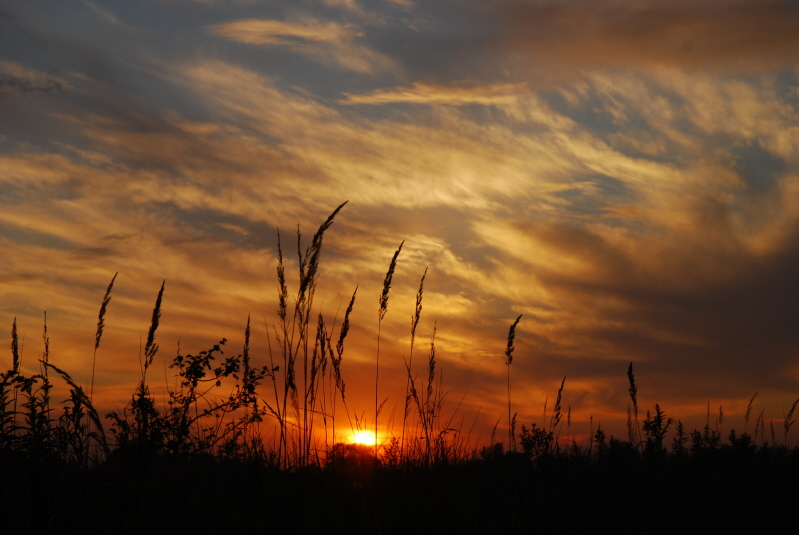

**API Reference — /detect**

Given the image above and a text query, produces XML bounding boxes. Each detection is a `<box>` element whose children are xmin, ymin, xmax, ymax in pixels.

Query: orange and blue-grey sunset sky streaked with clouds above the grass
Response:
<box><xmin>0</xmin><ymin>0</ymin><xmax>799</xmax><ymax>448</ymax></box>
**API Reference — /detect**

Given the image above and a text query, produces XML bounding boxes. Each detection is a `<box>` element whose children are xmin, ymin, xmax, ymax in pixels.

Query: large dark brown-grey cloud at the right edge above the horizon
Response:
<box><xmin>512</xmin><ymin>214</ymin><xmax>799</xmax><ymax>395</ymax></box>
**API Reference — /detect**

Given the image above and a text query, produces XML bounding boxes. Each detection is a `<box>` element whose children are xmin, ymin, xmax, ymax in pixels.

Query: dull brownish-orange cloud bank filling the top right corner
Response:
<box><xmin>484</xmin><ymin>0</ymin><xmax>799</xmax><ymax>74</ymax></box>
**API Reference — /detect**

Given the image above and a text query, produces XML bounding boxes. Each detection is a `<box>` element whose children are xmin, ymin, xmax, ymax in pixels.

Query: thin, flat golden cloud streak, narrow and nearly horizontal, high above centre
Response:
<box><xmin>342</xmin><ymin>82</ymin><xmax>525</xmax><ymax>106</ymax></box>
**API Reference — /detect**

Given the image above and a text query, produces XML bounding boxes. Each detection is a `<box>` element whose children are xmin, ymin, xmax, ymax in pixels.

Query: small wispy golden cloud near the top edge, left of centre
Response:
<box><xmin>210</xmin><ymin>17</ymin><xmax>393</xmax><ymax>74</ymax></box>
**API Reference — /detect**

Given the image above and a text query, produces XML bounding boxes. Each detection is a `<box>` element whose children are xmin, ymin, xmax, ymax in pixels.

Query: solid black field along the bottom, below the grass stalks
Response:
<box><xmin>0</xmin><ymin>443</ymin><xmax>799</xmax><ymax>534</ymax></box>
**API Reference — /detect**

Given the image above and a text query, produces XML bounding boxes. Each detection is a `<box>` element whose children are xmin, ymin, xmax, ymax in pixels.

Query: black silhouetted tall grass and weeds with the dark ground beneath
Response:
<box><xmin>0</xmin><ymin>204</ymin><xmax>799</xmax><ymax>534</ymax></box>
